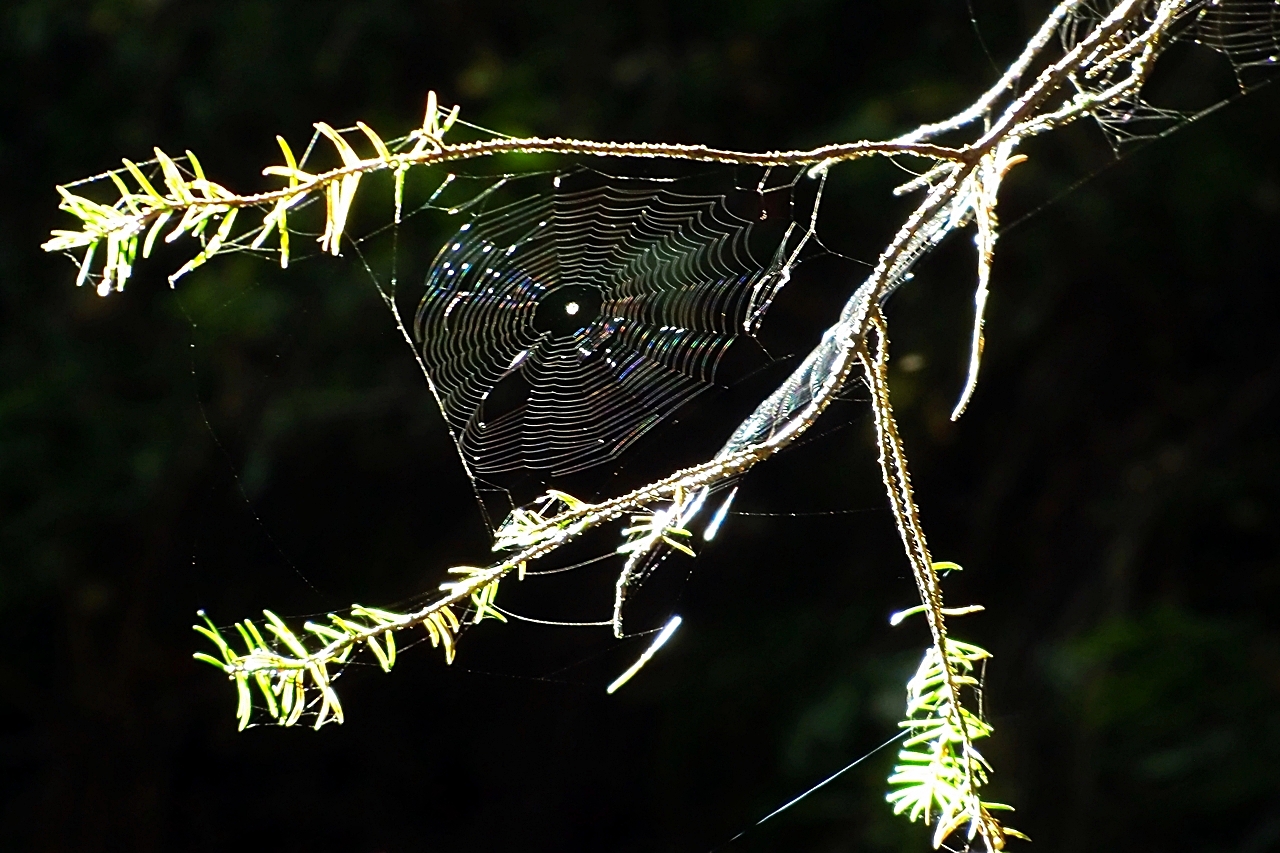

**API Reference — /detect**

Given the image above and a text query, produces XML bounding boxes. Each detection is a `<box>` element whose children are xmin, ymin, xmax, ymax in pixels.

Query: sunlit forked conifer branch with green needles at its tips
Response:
<box><xmin>45</xmin><ymin>0</ymin><xmax>1274</xmax><ymax>849</ymax></box>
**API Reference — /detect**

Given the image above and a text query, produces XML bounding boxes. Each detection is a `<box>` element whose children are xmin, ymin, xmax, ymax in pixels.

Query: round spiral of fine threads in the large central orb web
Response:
<box><xmin>413</xmin><ymin>170</ymin><xmax>805</xmax><ymax>476</ymax></box>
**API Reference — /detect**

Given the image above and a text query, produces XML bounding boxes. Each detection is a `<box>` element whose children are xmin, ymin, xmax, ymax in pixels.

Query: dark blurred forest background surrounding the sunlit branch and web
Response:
<box><xmin>0</xmin><ymin>0</ymin><xmax>1280</xmax><ymax>853</ymax></box>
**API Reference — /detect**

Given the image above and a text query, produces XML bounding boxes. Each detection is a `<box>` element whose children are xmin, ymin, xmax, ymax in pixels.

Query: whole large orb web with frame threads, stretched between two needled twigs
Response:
<box><xmin>335</xmin><ymin>146</ymin><xmax>844</xmax><ymax>529</ymax></box>
